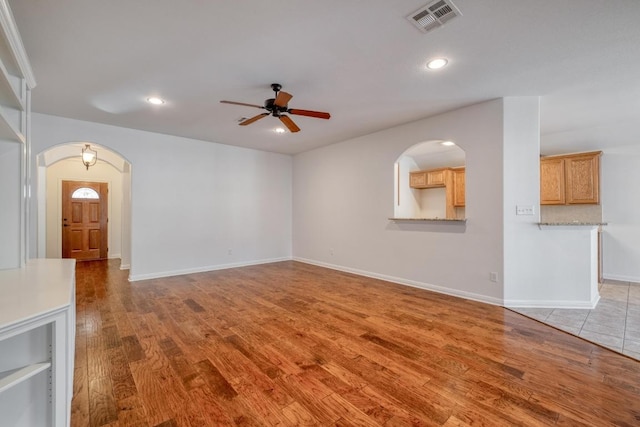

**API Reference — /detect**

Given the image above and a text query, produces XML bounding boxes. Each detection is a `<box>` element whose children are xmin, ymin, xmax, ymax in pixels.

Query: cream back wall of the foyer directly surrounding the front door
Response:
<box><xmin>46</xmin><ymin>159</ymin><xmax>123</xmax><ymax>258</ymax></box>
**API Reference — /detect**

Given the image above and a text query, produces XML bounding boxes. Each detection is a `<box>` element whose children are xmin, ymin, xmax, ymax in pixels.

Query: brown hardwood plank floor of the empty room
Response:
<box><xmin>72</xmin><ymin>261</ymin><xmax>640</xmax><ymax>427</ymax></box>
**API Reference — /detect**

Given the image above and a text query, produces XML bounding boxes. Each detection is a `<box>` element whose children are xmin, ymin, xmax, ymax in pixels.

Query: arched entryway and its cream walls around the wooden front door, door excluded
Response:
<box><xmin>36</xmin><ymin>141</ymin><xmax>131</xmax><ymax>270</ymax></box>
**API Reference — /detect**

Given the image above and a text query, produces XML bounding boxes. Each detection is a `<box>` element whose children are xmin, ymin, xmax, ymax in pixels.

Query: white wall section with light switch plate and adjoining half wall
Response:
<box><xmin>503</xmin><ymin>97</ymin><xmax>598</xmax><ymax>308</ymax></box>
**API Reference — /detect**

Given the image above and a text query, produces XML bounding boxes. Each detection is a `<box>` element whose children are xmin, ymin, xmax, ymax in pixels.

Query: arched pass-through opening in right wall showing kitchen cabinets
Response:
<box><xmin>393</xmin><ymin>140</ymin><xmax>466</xmax><ymax>220</ymax></box>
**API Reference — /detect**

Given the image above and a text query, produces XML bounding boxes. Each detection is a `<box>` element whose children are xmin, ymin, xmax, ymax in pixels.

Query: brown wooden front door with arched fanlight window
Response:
<box><xmin>62</xmin><ymin>181</ymin><xmax>108</xmax><ymax>260</ymax></box>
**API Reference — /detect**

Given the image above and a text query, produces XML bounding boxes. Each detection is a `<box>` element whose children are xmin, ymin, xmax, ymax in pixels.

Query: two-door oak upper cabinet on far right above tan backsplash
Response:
<box><xmin>540</xmin><ymin>151</ymin><xmax>602</xmax><ymax>205</ymax></box>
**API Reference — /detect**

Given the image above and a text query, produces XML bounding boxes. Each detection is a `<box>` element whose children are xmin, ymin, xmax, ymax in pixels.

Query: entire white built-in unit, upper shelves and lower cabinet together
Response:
<box><xmin>0</xmin><ymin>0</ymin><xmax>75</xmax><ymax>427</ymax></box>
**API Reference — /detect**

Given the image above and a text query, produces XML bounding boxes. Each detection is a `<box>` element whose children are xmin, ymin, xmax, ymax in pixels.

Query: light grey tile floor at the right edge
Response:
<box><xmin>512</xmin><ymin>280</ymin><xmax>640</xmax><ymax>360</ymax></box>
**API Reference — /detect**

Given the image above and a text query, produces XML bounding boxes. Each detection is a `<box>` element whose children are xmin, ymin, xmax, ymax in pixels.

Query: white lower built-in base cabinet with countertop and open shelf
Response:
<box><xmin>0</xmin><ymin>259</ymin><xmax>75</xmax><ymax>427</ymax></box>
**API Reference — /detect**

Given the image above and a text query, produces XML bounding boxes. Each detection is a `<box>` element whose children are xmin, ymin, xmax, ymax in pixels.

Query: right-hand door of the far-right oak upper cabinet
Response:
<box><xmin>565</xmin><ymin>154</ymin><xmax>600</xmax><ymax>204</ymax></box>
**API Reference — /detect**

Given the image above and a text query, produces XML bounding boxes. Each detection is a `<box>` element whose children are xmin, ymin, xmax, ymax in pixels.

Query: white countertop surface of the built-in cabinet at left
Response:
<box><xmin>0</xmin><ymin>259</ymin><xmax>76</xmax><ymax>331</ymax></box>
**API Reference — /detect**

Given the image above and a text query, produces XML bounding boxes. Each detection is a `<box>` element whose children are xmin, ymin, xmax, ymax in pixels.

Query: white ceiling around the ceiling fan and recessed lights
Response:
<box><xmin>9</xmin><ymin>0</ymin><xmax>640</xmax><ymax>153</ymax></box>
